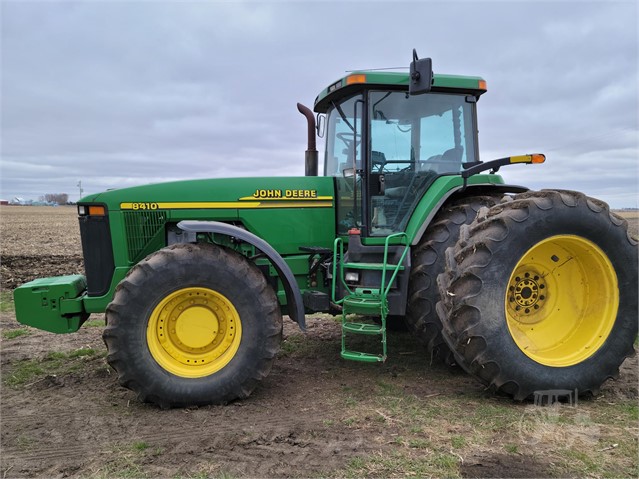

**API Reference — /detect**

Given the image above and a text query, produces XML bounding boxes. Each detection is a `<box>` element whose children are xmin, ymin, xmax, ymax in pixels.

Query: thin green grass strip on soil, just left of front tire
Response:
<box><xmin>2</xmin><ymin>348</ymin><xmax>106</xmax><ymax>388</ymax></box>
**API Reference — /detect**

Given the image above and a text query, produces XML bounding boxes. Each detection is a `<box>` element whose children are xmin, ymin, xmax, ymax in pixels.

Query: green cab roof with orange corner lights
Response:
<box><xmin>315</xmin><ymin>71</ymin><xmax>486</xmax><ymax>113</ymax></box>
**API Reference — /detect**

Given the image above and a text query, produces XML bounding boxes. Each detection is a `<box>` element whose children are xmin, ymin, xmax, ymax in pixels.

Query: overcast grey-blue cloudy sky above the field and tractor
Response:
<box><xmin>1</xmin><ymin>0</ymin><xmax>639</xmax><ymax>207</ymax></box>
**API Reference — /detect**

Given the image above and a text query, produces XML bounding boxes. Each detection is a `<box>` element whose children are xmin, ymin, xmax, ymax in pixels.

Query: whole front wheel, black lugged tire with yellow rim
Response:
<box><xmin>103</xmin><ymin>244</ymin><xmax>282</xmax><ymax>408</ymax></box>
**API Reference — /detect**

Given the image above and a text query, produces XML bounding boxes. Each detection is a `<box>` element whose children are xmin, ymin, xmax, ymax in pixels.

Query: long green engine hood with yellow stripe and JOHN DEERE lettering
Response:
<box><xmin>79</xmin><ymin>176</ymin><xmax>335</xmax><ymax>263</ymax></box>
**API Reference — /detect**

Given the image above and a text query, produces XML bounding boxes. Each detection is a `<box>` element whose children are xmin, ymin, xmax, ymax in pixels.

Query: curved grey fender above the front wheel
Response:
<box><xmin>177</xmin><ymin>221</ymin><xmax>306</xmax><ymax>331</ymax></box>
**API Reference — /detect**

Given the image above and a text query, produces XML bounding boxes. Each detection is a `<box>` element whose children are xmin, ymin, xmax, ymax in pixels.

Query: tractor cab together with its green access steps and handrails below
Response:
<box><xmin>315</xmin><ymin>62</ymin><xmax>486</xmax><ymax>362</ymax></box>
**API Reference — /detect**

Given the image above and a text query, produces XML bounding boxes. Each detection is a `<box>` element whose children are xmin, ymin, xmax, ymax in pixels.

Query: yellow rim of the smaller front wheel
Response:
<box><xmin>146</xmin><ymin>287</ymin><xmax>242</xmax><ymax>378</ymax></box>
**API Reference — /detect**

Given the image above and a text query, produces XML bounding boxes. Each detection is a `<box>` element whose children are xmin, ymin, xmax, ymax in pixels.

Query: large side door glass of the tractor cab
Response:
<box><xmin>368</xmin><ymin>91</ymin><xmax>475</xmax><ymax>235</ymax></box>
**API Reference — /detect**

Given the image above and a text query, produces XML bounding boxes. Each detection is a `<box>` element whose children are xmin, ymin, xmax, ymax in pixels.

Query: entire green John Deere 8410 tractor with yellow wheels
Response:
<box><xmin>15</xmin><ymin>52</ymin><xmax>637</xmax><ymax>407</ymax></box>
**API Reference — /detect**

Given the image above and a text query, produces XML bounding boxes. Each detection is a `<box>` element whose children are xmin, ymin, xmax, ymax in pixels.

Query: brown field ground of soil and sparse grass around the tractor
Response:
<box><xmin>0</xmin><ymin>207</ymin><xmax>639</xmax><ymax>479</ymax></box>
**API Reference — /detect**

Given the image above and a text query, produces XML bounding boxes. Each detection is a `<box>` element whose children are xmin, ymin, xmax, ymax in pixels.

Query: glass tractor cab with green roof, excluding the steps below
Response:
<box><xmin>315</xmin><ymin>72</ymin><xmax>486</xmax><ymax>237</ymax></box>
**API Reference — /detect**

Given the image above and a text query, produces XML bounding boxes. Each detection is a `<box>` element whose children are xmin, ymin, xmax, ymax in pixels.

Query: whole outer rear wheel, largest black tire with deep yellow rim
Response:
<box><xmin>437</xmin><ymin>190</ymin><xmax>637</xmax><ymax>400</ymax></box>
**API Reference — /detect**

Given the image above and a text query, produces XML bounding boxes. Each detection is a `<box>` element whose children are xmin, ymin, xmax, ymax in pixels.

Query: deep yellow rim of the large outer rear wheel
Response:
<box><xmin>506</xmin><ymin>235</ymin><xmax>619</xmax><ymax>367</ymax></box>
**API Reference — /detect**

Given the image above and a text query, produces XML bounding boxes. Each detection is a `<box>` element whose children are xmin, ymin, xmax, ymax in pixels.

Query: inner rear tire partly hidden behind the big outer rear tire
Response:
<box><xmin>405</xmin><ymin>196</ymin><xmax>499</xmax><ymax>366</ymax></box>
